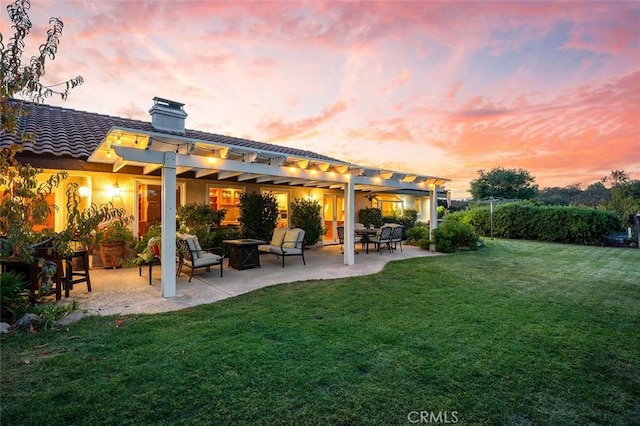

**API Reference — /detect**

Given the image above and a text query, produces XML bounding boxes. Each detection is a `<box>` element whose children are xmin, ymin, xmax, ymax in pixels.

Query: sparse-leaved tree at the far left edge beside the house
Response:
<box><xmin>0</xmin><ymin>0</ymin><xmax>83</xmax><ymax>261</ymax></box>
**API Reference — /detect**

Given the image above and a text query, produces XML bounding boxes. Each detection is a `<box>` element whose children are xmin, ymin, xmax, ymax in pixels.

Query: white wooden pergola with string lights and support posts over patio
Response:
<box><xmin>88</xmin><ymin>127</ymin><xmax>449</xmax><ymax>297</ymax></box>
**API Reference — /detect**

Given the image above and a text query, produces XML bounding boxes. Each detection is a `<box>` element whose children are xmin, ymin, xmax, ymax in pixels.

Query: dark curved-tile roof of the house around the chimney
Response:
<box><xmin>0</xmin><ymin>103</ymin><xmax>340</xmax><ymax>162</ymax></box>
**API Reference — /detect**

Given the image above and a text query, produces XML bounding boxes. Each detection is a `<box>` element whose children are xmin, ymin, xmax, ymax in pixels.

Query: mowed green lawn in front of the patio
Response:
<box><xmin>0</xmin><ymin>240</ymin><xmax>640</xmax><ymax>425</ymax></box>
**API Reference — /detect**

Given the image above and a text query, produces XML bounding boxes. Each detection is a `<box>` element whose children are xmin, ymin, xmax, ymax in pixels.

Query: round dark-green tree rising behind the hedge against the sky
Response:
<box><xmin>470</xmin><ymin>167</ymin><xmax>538</xmax><ymax>200</ymax></box>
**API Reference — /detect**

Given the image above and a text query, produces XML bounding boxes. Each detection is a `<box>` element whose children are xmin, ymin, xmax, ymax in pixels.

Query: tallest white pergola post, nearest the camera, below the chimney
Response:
<box><xmin>160</xmin><ymin>151</ymin><xmax>176</xmax><ymax>297</ymax></box>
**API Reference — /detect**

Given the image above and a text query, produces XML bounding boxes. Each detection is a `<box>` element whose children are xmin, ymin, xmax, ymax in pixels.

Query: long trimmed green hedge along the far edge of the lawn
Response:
<box><xmin>450</xmin><ymin>202</ymin><xmax>621</xmax><ymax>245</ymax></box>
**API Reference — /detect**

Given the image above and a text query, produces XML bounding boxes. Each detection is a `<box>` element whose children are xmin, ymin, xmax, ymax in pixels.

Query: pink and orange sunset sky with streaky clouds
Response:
<box><xmin>0</xmin><ymin>0</ymin><xmax>640</xmax><ymax>198</ymax></box>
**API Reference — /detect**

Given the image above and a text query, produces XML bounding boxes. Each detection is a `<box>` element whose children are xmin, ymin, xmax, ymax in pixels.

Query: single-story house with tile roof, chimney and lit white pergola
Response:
<box><xmin>0</xmin><ymin>97</ymin><xmax>448</xmax><ymax>297</ymax></box>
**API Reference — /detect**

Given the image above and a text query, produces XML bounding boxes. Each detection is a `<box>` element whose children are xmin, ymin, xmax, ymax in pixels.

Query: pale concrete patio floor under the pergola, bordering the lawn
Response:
<box><xmin>62</xmin><ymin>245</ymin><xmax>439</xmax><ymax>315</ymax></box>
